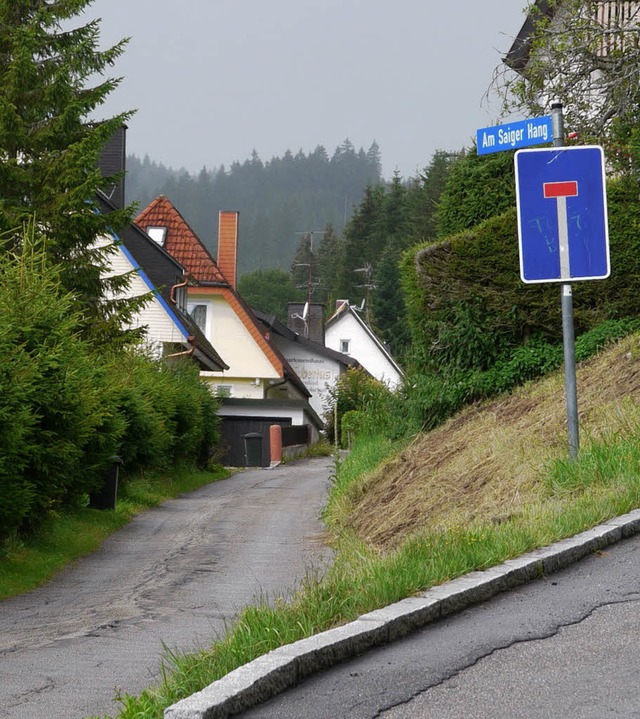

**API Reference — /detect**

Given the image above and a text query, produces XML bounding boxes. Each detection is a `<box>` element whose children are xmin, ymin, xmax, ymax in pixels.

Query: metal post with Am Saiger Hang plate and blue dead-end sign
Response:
<box><xmin>476</xmin><ymin>103</ymin><xmax>610</xmax><ymax>459</ymax></box>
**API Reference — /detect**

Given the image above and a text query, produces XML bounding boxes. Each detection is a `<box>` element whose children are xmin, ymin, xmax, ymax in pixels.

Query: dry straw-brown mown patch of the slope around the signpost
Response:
<box><xmin>330</xmin><ymin>335</ymin><xmax>640</xmax><ymax>553</ymax></box>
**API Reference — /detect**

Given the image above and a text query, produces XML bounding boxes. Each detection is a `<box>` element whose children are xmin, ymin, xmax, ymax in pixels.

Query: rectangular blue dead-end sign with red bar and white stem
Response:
<box><xmin>515</xmin><ymin>146</ymin><xmax>610</xmax><ymax>283</ymax></box>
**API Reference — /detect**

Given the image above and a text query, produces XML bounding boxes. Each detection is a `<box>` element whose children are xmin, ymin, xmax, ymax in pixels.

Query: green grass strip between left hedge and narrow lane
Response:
<box><xmin>0</xmin><ymin>468</ymin><xmax>228</xmax><ymax>600</ymax></box>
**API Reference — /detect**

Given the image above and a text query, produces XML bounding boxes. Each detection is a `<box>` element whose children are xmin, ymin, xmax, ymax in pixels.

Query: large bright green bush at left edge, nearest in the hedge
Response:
<box><xmin>0</xmin><ymin>233</ymin><xmax>124</xmax><ymax>536</ymax></box>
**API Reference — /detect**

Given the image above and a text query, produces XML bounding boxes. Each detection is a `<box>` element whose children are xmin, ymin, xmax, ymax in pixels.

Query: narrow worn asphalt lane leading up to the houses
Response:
<box><xmin>0</xmin><ymin>458</ymin><xmax>331</xmax><ymax>719</ymax></box>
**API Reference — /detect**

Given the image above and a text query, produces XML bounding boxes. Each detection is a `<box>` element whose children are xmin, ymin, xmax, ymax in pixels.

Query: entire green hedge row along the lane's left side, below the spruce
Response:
<box><xmin>0</xmin><ymin>233</ymin><xmax>219</xmax><ymax>540</ymax></box>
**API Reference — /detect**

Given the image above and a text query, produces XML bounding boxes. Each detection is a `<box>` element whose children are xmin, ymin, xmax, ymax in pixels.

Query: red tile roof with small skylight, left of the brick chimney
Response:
<box><xmin>135</xmin><ymin>200</ymin><xmax>228</xmax><ymax>284</ymax></box>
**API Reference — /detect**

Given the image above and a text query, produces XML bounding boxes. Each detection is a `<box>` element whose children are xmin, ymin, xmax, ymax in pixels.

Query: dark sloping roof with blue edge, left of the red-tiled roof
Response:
<box><xmin>96</xmin><ymin>192</ymin><xmax>229</xmax><ymax>371</ymax></box>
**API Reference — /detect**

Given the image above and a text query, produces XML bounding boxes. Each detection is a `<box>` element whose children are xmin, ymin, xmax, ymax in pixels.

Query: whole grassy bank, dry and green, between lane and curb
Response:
<box><xmin>91</xmin><ymin>338</ymin><xmax>640</xmax><ymax>719</ymax></box>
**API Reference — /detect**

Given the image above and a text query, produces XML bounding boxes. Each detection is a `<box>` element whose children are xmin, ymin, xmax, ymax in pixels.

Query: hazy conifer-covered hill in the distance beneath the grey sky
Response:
<box><xmin>126</xmin><ymin>140</ymin><xmax>381</xmax><ymax>274</ymax></box>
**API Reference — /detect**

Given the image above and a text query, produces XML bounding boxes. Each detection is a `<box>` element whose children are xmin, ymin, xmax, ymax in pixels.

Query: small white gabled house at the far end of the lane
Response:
<box><xmin>325</xmin><ymin>300</ymin><xmax>404</xmax><ymax>390</ymax></box>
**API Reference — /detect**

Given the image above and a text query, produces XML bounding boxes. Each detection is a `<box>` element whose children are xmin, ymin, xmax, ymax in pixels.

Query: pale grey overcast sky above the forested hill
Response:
<box><xmin>87</xmin><ymin>0</ymin><xmax>527</xmax><ymax>178</ymax></box>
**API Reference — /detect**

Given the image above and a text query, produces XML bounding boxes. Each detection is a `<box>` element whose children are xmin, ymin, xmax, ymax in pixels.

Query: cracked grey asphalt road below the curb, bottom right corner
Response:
<box><xmin>242</xmin><ymin>536</ymin><xmax>640</xmax><ymax>719</ymax></box>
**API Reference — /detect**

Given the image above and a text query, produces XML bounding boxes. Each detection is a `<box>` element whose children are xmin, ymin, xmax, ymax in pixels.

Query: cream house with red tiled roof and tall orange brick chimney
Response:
<box><xmin>136</xmin><ymin>196</ymin><xmax>323</xmax><ymax>464</ymax></box>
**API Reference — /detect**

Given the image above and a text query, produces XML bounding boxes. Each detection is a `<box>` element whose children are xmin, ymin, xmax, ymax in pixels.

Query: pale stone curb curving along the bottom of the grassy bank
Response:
<box><xmin>164</xmin><ymin>510</ymin><xmax>640</xmax><ymax>719</ymax></box>
